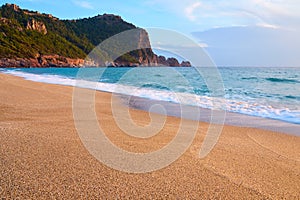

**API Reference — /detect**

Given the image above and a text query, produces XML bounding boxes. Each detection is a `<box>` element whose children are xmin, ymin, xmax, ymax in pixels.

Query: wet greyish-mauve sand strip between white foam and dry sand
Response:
<box><xmin>117</xmin><ymin>94</ymin><xmax>300</xmax><ymax>136</ymax></box>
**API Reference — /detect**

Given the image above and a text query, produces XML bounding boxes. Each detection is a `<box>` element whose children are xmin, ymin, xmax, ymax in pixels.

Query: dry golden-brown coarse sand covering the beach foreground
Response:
<box><xmin>0</xmin><ymin>74</ymin><xmax>300</xmax><ymax>199</ymax></box>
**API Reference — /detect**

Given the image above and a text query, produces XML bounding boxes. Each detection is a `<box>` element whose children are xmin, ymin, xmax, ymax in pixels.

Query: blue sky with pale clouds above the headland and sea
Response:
<box><xmin>0</xmin><ymin>0</ymin><xmax>300</xmax><ymax>67</ymax></box>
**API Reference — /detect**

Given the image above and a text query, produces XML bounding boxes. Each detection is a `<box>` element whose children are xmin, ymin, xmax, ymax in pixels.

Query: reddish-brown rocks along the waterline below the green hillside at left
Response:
<box><xmin>0</xmin><ymin>55</ymin><xmax>85</xmax><ymax>68</ymax></box>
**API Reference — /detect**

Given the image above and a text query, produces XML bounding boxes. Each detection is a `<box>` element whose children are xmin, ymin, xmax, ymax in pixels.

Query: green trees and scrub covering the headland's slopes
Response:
<box><xmin>0</xmin><ymin>4</ymin><xmax>153</xmax><ymax>62</ymax></box>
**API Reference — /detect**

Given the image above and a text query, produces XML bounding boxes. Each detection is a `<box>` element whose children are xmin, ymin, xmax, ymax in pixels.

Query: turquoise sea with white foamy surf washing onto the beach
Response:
<box><xmin>0</xmin><ymin>67</ymin><xmax>300</xmax><ymax>135</ymax></box>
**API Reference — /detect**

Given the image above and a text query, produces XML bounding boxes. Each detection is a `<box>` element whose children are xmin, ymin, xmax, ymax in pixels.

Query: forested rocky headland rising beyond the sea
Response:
<box><xmin>0</xmin><ymin>4</ymin><xmax>190</xmax><ymax>67</ymax></box>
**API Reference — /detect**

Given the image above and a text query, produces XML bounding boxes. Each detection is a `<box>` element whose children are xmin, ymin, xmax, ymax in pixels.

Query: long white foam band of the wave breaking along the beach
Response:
<box><xmin>1</xmin><ymin>70</ymin><xmax>300</xmax><ymax>124</ymax></box>
